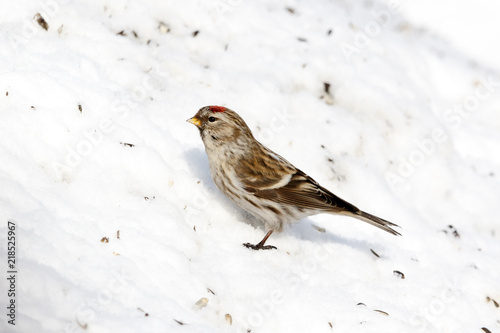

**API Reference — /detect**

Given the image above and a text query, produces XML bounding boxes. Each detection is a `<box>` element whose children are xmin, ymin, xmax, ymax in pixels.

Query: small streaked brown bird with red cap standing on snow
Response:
<box><xmin>187</xmin><ymin>106</ymin><xmax>400</xmax><ymax>250</ymax></box>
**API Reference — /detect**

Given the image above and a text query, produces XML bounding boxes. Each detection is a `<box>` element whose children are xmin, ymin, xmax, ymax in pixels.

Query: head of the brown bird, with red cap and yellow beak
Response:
<box><xmin>187</xmin><ymin>106</ymin><xmax>253</xmax><ymax>148</ymax></box>
